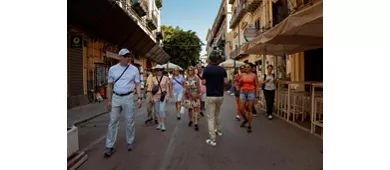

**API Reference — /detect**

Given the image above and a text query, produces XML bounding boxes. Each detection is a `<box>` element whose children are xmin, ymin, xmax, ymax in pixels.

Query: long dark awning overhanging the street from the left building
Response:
<box><xmin>68</xmin><ymin>0</ymin><xmax>170</xmax><ymax>64</ymax></box>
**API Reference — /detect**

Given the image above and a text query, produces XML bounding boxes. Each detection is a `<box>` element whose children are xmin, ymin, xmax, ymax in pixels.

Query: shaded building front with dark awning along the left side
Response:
<box><xmin>67</xmin><ymin>0</ymin><xmax>169</xmax><ymax>108</ymax></box>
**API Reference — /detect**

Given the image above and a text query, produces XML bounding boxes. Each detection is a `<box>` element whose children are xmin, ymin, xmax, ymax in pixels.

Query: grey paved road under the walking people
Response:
<box><xmin>79</xmin><ymin>96</ymin><xmax>323</xmax><ymax>170</ymax></box>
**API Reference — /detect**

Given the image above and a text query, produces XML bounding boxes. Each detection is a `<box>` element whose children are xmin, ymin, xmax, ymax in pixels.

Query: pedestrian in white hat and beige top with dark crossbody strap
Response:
<box><xmin>152</xmin><ymin>65</ymin><xmax>171</xmax><ymax>132</ymax></box>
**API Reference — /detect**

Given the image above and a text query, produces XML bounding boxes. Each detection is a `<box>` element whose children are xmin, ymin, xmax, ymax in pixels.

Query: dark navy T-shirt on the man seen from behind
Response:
<box><xmin>202</xmin><ymin>64</ymin><xmax>227</xmax><ymax>97</ymax></box>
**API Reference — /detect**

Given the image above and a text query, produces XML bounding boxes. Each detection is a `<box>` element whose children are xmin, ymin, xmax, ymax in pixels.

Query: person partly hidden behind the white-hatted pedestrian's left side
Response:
<box><xmin>145</xmin><ymin>69</ymin><xmax>158</xmax><ymax>124</ymax></box>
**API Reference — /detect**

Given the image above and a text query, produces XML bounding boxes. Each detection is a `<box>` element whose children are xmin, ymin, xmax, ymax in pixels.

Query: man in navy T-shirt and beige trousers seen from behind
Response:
<box><xmin>202</xmin><ymin>52</ymin><xmax>227</xmax><ymax>146</ymax></box>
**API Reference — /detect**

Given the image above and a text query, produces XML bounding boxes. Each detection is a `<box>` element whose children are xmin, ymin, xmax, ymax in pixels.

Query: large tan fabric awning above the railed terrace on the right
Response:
<box><xmin>242</xmin><ymin>1</ymin><xmax>323</xmax><ymax>55</ymax></box>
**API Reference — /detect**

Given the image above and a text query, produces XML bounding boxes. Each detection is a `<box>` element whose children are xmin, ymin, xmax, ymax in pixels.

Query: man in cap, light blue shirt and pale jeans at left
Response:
<box><xmin>104</xmin><ymin>49</ymin><xmax>142</xmax><ymax>157</ymax></box>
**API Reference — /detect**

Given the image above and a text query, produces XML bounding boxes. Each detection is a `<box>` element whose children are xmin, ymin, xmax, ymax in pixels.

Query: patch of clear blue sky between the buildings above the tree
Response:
<box><xmin>160</xmin><ymin>0</ymin><xmax>221</xmax><ymax>55</ymax></box>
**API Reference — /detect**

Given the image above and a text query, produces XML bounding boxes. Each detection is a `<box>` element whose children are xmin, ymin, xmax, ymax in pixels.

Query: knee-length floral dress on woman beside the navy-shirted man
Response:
<box><xmin>182</xmin><ymin>76</ymin><xmax>200</xmax><ymax>109</ymax></box>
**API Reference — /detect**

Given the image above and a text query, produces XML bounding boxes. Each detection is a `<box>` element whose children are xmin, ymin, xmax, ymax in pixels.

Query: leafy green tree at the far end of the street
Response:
<box><xmin>161</xmin><ymin>26</ymin><xmax>204</xmax><ymax>69</ymax></box>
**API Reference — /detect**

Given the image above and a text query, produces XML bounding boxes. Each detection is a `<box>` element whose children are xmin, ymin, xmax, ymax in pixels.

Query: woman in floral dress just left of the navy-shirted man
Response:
<box><xmin>182</xmin><ymin>66</ymin><xmax>201</xmax><ymax>131</ymax></box>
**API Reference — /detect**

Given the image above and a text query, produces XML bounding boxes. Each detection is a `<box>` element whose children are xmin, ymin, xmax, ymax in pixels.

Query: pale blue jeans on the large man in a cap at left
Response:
<box><xmin>106</xmin><ymin>93</ymin><xmax>136</xmax><ymax>148</ymax></box>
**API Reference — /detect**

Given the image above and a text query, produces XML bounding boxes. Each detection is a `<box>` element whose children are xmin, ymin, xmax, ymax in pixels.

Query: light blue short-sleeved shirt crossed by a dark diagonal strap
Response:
<box><xmin>108</xmin><ymin>64</ymin><xmax>140</xmax><ymax>94</ymax></box>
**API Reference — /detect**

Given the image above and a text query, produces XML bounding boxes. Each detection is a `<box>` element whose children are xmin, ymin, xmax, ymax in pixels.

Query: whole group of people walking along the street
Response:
<box><xmin>104</xmin><ymin>49</ymin><xmax>276</xmax><ymax>157</ymax></box>
